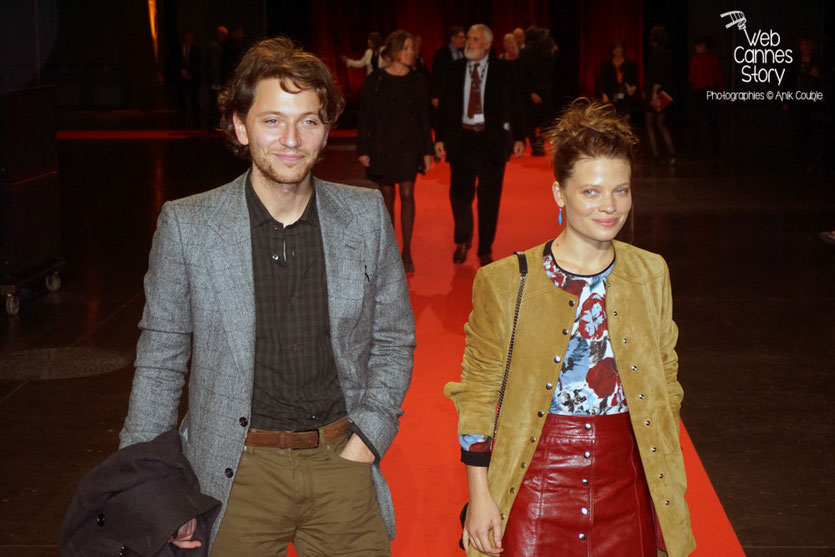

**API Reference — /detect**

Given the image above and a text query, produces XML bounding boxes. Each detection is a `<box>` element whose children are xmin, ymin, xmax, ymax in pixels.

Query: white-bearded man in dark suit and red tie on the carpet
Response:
<box><xmin>435</xmin><ymin>24</ymin><xmax>525</xmax><ymax>265</ymax></box>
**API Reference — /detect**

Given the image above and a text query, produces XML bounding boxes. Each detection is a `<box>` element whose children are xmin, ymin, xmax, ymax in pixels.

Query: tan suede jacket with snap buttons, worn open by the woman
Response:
<box><xmin>444</xmin><ymin>241</ymin><xmax>696</xmax><ymax>557</ymax></box>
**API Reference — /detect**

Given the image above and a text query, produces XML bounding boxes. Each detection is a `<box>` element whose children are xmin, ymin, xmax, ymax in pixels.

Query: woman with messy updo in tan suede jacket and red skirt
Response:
<box><xmin>444</xmin><ymin>99</ymin><xmax>695</xmax><ymax>557</ymax></box>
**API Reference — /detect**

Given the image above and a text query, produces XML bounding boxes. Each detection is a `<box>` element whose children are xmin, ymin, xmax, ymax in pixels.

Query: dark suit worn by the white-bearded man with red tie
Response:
<box><xmin>435</xmin><ymin>57</ymin><xmax>525</xmax><ymax>256</ymax></box>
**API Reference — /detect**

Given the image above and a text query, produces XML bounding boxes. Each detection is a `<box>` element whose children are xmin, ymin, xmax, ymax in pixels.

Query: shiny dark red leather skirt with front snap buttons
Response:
<box><xmin>502</xmin><ymin>413</ymin><xmax>656</xmax><ymax>557</ymax></box>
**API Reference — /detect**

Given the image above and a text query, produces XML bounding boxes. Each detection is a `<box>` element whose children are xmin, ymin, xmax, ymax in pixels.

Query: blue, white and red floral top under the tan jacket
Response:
<box><xmin>458</xmin><ymin>244</ymin><xmax>629</xmax><ymax>454</ymax></box>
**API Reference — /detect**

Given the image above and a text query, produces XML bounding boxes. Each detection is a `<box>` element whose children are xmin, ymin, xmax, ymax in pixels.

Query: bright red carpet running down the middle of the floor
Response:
<box><xmin>383</xmin><ymin>155</ymin><xmax>744</xmax><ymax>557</ymax></box>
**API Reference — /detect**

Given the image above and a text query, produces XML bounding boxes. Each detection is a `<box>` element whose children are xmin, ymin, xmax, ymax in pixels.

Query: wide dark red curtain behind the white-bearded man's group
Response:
<box><xmin>307</xmin><ymin>0</ymin><xmax>550</xmax><ymax>103</ymax></box>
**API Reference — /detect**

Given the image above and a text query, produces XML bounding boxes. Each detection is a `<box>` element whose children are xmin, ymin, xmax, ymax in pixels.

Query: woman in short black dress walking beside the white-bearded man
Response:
<box><xmin>357</xmin><ymin>31</ymin><xmax>434</xmax><ymax>273</ymax></box>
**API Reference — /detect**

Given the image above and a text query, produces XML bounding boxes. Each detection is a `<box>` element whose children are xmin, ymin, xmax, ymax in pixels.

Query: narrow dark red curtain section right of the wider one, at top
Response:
<box><xmin>578</xmin><ymin>0</ymin><xmax>644</xmax><ymax>95</ymax></box>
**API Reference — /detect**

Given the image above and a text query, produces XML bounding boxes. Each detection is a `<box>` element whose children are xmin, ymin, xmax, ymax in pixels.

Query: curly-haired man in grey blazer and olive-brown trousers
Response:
<box><xmin>121</xmin><ymin>38</ymin><xmax>415</xmax><ymax>556</ymax></box>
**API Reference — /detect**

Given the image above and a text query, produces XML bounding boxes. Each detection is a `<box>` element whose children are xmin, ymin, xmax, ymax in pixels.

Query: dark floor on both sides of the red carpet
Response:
<box><xmin>0</xmin><ymin>134</ymin><xmax>835</xmax><ymax>557</ymax></box>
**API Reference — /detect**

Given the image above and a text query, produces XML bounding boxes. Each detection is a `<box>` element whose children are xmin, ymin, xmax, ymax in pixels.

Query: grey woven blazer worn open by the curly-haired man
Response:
<box><xmin>120</xmin><ymin>174</ymin><xmax>415</xmax><ymax>543</ymax></box>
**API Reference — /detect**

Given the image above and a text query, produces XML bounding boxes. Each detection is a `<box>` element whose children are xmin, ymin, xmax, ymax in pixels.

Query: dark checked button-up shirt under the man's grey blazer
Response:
<box><xmin>246</xmin><ymin>178</ymin><xmax>347</xmax><ymax>431</ymax></box>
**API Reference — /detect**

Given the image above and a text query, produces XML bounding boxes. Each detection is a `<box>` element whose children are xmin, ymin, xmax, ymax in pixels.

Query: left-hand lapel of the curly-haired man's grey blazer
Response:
<box><xmin>206</xmin><ymin>173</ymin><xmax>255</xmax><ymax>377</ymax></box>
